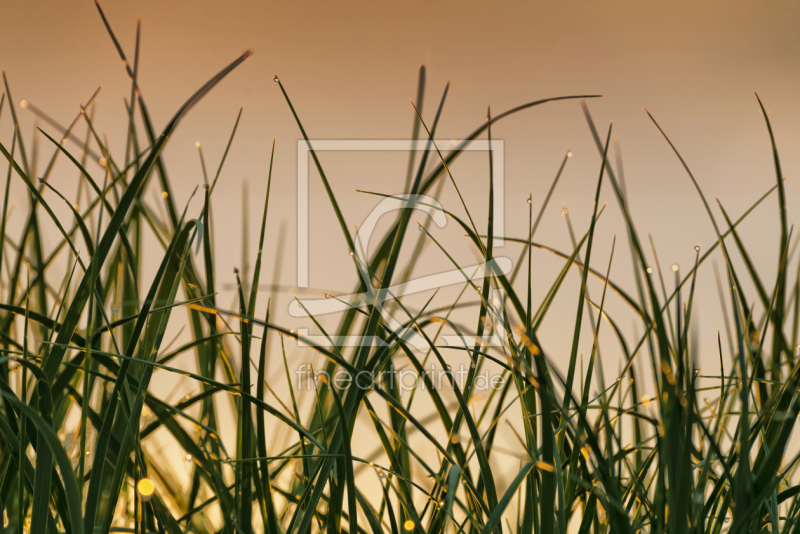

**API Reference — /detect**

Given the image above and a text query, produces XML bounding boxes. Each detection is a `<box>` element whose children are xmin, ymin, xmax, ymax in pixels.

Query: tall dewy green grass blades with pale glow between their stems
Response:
<box><xmin>0</xmin><ymin>5</ymin><xmax>800</xmax><ymax>534</ymax></box>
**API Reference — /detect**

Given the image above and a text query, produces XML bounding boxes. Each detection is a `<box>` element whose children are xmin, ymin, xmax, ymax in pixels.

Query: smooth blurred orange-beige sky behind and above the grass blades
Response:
<box><xmin>0</xmin><ymin>0</ymin><xmax>800</xmax><ymax>492</ymax></box>
